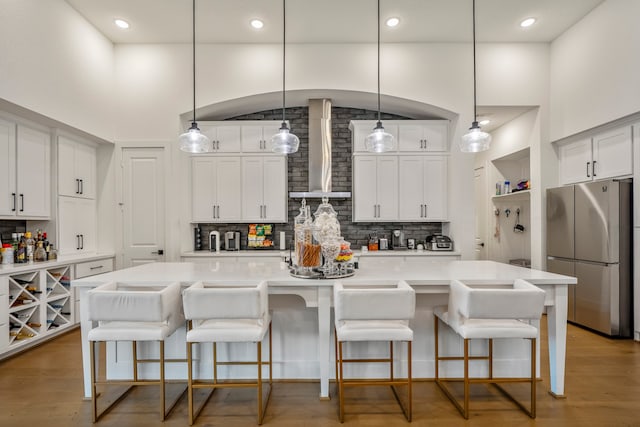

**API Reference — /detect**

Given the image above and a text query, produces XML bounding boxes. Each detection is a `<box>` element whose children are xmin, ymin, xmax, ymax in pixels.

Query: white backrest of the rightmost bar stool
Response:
<box><xmin>448</xmin><ymin>279</ymin><xmax>545</xmax><ymax>328</ymax></box>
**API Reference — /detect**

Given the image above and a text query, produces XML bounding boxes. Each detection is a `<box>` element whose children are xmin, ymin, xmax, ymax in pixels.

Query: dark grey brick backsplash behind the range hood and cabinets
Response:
<box><xmin>198</xmin><ymin>107</ymin><xmax>442</xmax><ymax>249</ymax></box>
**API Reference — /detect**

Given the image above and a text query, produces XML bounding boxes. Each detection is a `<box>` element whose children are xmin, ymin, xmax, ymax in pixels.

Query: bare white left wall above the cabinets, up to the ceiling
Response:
<box><xmin>0</xmin><ymin>0</ymin><xmax>115</xmax><ymax>140</ymax></box>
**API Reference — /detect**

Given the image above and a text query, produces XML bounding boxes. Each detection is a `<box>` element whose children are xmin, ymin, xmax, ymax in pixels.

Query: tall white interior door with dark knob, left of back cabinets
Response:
<box><xmin>122</xmin><ymin>147</ymin><xmax>166</xmax><ymax>268</ymax></box>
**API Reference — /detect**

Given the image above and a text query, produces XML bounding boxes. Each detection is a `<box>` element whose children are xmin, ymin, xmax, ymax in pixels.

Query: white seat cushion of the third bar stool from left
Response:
<box><xmin>336</xmin><ymin>320</ymin><xmax>413</xmax><ymax>341</ymax></box>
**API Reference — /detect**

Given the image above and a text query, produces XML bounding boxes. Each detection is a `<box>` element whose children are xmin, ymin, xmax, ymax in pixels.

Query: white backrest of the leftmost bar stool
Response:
<box><xmin>88</xmin><ymin>282</ymin><xmax>182</xmax><ymax>322</ymax></box>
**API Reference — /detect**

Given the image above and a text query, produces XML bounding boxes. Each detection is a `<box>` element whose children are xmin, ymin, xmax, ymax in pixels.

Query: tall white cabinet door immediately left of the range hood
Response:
<box><xmin>262</xmin><ymin>156</ymin><xmax>287</xmax><ymax>222</ymax></box>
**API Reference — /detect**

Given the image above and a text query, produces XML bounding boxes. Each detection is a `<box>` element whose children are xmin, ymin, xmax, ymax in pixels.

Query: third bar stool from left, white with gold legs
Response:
<box><xmin>333</xmin><ymin>281</ymin><xmax>416</xmax><ymax>422</ymax></box>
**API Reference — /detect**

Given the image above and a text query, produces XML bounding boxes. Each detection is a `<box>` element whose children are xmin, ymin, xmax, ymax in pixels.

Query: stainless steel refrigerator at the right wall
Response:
<box><xmin>547</xmin><ymin>180</ymin><xmax>633</xmax><ymax>337</ymax></box>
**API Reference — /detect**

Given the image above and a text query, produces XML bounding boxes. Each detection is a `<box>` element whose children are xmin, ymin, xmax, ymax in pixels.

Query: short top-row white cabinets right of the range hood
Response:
<box><xmin>349</xmin><ymin>120</ymin><xmax>449</xmax><ymax>153</ymax></box>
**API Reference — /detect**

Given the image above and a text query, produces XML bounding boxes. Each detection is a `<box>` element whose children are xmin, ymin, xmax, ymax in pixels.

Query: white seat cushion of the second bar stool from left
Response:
<box><xmin>187</xmin><ymin>314</ymin><xmax>271</xmax><ymax>342</ymax></box>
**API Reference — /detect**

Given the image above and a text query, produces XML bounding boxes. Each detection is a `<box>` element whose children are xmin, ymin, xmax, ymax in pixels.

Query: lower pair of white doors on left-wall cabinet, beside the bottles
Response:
<box><xmin>58</xmin><ymin>196</ymin><xmax>97</xmax><ymax>255</ymax></box>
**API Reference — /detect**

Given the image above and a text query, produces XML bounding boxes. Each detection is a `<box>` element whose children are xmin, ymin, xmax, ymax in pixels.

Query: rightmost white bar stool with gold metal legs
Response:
<box><xmin>434</xmin><ymin>279</ymin><xmax>544</xmax><ymax>419</ymax></box>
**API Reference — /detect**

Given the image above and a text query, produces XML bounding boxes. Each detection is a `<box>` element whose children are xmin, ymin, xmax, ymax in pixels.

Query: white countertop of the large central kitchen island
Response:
<box><xmin>72</xmin><ymin>260</ymin><xmax>577</xmax><ymax>287</ymax></box>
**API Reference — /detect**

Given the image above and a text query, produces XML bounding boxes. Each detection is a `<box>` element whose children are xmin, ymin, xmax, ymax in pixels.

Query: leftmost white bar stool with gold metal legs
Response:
<box><xmin>88</xmin><ymin>282</ymin><xmax>186</xmax><ymax>423</ymax></box>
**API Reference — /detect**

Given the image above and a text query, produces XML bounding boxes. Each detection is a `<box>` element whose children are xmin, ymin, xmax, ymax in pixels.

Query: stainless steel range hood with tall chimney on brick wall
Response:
<box><xmin>289</xmin><ymin>99</ymin><xmax>351</xmax><ymax>199</ymax></box>
